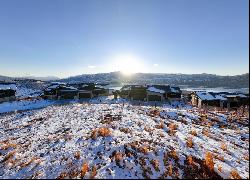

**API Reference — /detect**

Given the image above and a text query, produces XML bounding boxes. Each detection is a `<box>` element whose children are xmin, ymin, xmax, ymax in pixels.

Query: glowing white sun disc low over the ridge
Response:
<box><xmin>113</xmin><ymin>54</ymin><xmax>142</xmax><ymax>76</ymax></box>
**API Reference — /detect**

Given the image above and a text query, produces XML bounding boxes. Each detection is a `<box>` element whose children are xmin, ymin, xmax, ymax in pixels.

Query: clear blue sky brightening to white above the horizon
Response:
<box><xmin>0</xmin><ymin>0</ymin><xmax>249</xmax><ymax>77</ymax></box>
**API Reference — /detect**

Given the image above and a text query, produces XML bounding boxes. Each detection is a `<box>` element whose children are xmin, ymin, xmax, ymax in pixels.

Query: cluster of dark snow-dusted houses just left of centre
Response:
<box><xmin>43</xmin><ymin>83</ymin><xmax>109</xmax><ymax>100</ymax></box>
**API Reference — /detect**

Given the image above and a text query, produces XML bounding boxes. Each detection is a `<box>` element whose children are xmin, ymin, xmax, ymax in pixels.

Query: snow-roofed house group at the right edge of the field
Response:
<box><xmin>191</xmin><ymin>91</ymin><xmax>249</xmax><ymax>108</ymax></box>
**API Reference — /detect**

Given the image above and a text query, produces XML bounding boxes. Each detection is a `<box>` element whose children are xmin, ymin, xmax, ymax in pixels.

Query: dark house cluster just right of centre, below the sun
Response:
<box><xmin>119</xmin><ymin>85</ymin><xmax>182</xmax><ymax>101</ymax></box>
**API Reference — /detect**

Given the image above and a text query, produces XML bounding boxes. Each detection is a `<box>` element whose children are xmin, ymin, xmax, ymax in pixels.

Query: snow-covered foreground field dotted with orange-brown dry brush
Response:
<box><xmin>0</xmin><ymin>99</ymin><xmax>249</xmax><ymax>179</ymax></box>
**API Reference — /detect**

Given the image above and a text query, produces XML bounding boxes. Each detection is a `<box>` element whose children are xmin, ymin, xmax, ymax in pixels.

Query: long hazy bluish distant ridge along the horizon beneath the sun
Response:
<box><xmin>60</xmin><ymin>72</ymin><xmax>249</xmax><ymax>89</ymax></box>
